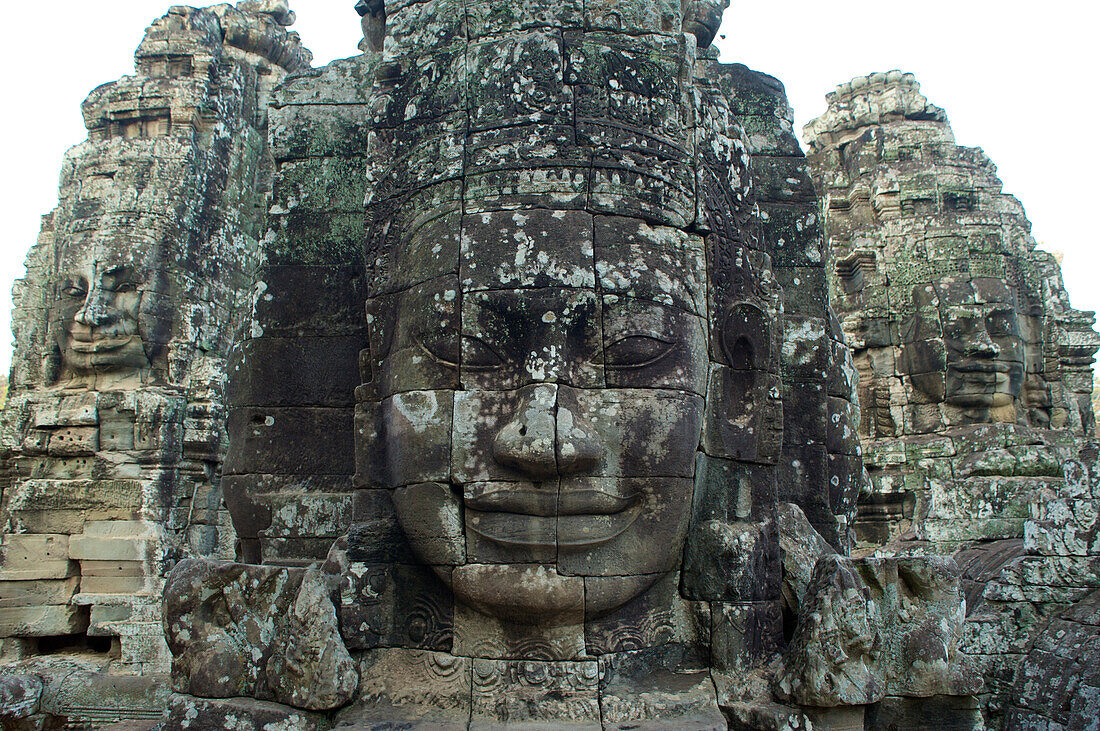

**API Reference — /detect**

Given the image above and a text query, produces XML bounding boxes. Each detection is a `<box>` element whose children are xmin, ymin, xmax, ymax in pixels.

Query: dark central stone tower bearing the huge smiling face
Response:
<box><xmin>180</xmin><ymin>0</ymin><xmax>981</xmax><ymax>728</ymax></box>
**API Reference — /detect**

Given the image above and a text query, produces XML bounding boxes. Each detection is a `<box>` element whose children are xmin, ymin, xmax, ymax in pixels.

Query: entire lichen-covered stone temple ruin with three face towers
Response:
<box><xmin>0</xmin><ymin>0</ymin><xmax>1100</xmax><ymax>731</ymax></box>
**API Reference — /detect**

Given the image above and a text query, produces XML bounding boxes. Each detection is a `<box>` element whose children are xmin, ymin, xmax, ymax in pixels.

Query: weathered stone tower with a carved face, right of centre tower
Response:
<box><xmin>805</xmin><ymin>71</ymin><xmax>1100</xmax><ymax>728</ymax></box>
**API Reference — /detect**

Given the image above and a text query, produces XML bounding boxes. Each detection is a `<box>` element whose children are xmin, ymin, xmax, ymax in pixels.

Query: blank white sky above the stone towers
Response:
<box><xmin>0</xmin><ymin>0</ymin><xmax>1100</xmax><ymax>373</ymax></box>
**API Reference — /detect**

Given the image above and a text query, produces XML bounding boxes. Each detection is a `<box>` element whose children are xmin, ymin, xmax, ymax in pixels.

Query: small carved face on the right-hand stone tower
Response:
<box><xmin>903</xmin><ymin>278</ymin><xmax>1024</xmax><ymax>421</ymax></box>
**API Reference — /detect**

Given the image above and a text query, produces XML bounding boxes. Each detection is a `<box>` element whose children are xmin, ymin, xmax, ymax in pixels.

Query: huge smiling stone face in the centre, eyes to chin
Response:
<box><xmin>367</xmin><ymin>211</ymin><xmax>708</xmax><ymax>623</ymax></box>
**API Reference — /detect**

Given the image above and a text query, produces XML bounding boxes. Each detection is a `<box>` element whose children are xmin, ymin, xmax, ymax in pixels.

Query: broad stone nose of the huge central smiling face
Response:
<box><xmin>493</xmin><ymin>384</ymin><xmax>600</xmax><ymax>479</ymax></box>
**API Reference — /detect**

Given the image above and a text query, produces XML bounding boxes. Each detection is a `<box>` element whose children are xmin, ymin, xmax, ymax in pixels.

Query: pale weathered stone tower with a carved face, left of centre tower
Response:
<box><xmin>0</xmin><ymin>2</ymin><xmax>310</xmax><ymax>723</ymax></box>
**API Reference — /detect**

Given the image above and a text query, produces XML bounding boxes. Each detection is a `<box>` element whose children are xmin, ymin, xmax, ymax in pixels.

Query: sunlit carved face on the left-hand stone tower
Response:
<box><xmin>51</xmin><ymin>241</ymin><xmax>150</xmax><ymax>376</ymax></box>
